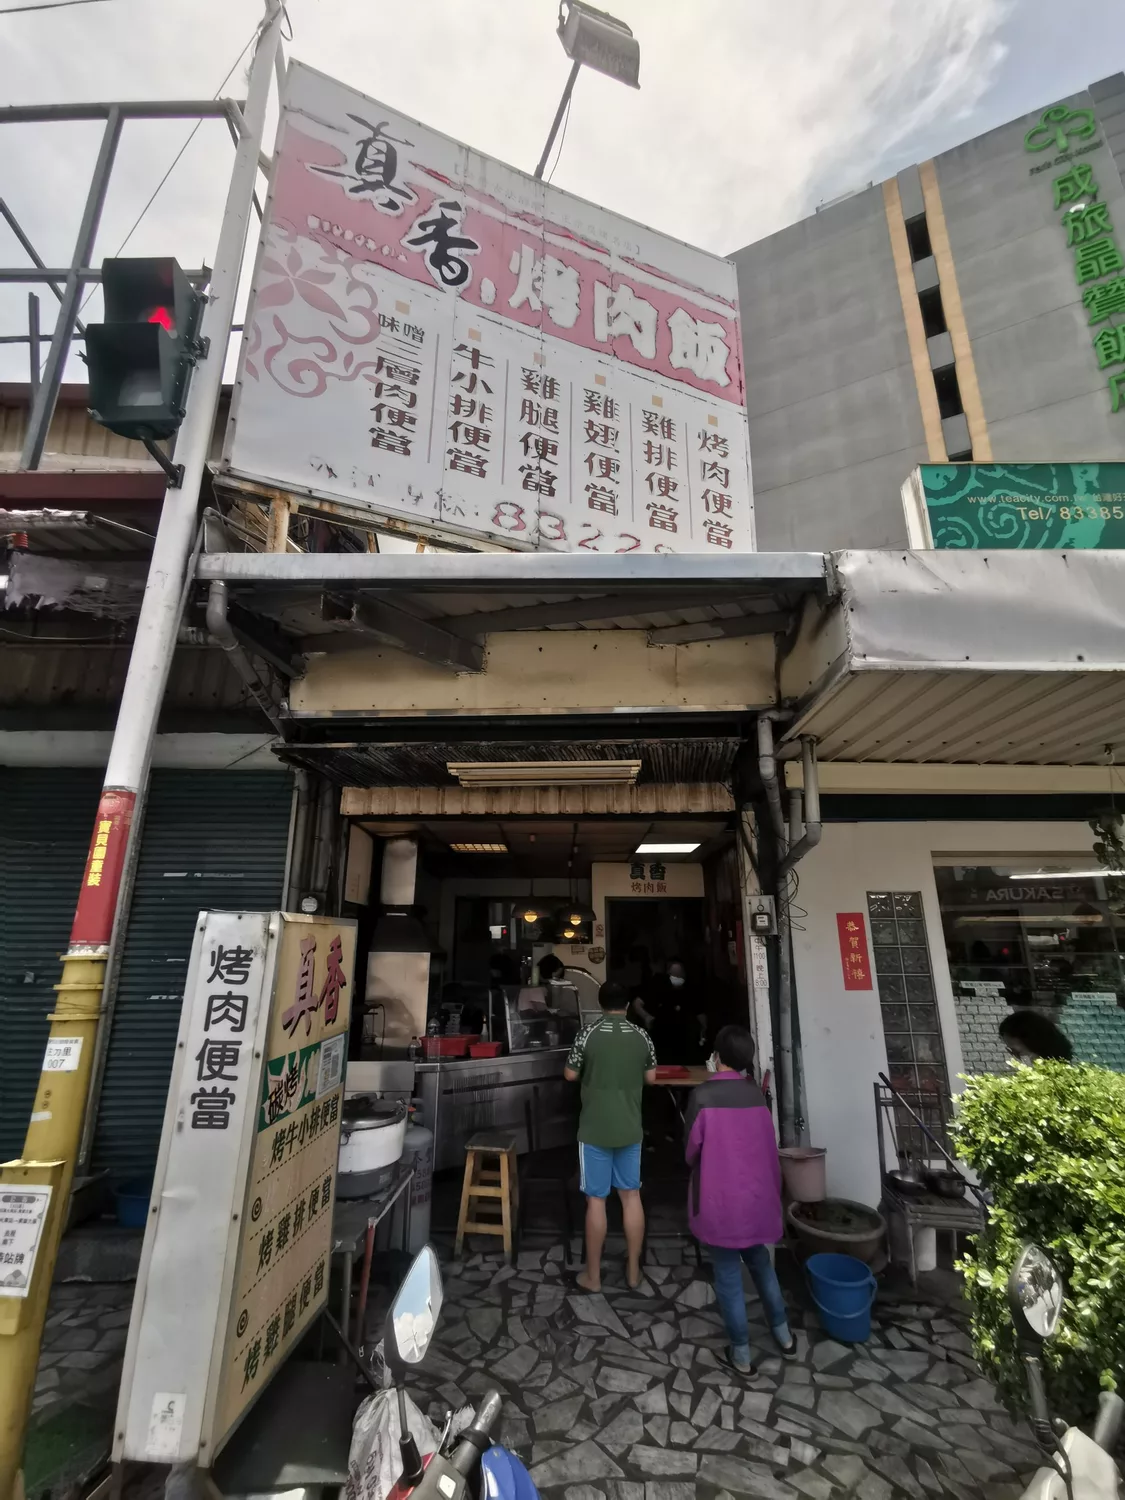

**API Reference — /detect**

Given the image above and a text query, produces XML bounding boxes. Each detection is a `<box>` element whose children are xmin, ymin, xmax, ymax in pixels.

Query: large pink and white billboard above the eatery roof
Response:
<box><xmin>224</xmin><ymin>65</ymin><xmax>755</xmax><ymax>554</ymax></box>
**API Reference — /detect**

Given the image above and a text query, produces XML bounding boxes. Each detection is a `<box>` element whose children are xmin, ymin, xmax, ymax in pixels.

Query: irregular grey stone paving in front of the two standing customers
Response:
<box><xmin>411</xmin><ymin>1247</ymin><xmax>1037</xmax><ymax>1500</ymax></box>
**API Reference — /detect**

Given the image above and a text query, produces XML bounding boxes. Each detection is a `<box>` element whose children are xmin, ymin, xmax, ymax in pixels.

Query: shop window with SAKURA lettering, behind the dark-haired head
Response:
<box><xmin>935</xmin><ymin>857</ymin><xmax>1125</xmax><ymax>1073</ymax></box>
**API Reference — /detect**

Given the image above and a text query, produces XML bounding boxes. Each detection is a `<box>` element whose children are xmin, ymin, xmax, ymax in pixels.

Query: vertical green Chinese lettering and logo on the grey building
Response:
<box><xmin>1023</xmin><ymin>105</ymin><xmax>1125</xmax><ymax>411</ymax></box>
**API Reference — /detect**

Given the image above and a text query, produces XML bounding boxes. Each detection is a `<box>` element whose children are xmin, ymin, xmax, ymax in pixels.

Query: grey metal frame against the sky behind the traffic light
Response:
<box><xmin>0</xmin><ymin>99</ymin><xmax>246</xmax><ymax>471</ymax></box>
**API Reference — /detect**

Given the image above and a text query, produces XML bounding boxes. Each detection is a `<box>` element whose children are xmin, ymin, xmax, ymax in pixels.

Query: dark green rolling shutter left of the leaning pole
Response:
<box><xmin>0</xmin><ymin>767</ymin><xmax>102</xmax><ymax>1161</ymax></box>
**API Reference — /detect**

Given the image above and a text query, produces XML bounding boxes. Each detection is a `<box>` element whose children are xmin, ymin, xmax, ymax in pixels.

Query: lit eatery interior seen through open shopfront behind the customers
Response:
<box><xmin>342</xmin><ymin>797</ymin><xmax>750</xmax><ymax>1194</ymax></box>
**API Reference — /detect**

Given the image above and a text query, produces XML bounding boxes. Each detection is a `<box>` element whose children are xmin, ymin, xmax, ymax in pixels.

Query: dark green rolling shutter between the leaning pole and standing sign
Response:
<box><xmin>92</xmin><ymin>771</ymin><xmax>293</xmax><ymax>1179</ymax></box>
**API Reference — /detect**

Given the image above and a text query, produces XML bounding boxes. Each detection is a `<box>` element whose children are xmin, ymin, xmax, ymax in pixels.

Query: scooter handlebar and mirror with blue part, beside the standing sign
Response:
<box><xmin>383</xmin><ymin>1245</ymin><xmax>539</xmax><ymax>1500</ymax></box>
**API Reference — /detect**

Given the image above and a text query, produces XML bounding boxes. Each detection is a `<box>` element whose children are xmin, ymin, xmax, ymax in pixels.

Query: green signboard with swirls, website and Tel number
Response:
<box><xmin>903</xmin><ymin>464</ymin><xmax>1125</xmax><ymax>551</ymax></box>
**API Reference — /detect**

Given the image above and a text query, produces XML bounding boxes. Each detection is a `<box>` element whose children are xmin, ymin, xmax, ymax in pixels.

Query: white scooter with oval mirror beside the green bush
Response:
<box><xmin>1008</xmin><ymin>1245</ymin><xmax>1125</xmax><ymax>1500</ymax></box>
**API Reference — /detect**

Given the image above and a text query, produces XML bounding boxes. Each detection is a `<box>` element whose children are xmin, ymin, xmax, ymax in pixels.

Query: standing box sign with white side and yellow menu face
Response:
<box><xmin>114</xmin><ymin>912</ymin><xmax>356</xmax><ymax>1463</ymax></box>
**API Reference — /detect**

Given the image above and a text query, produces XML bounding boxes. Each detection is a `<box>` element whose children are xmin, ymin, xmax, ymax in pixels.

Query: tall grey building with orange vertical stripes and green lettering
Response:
<box><xmin>732</xmin><ymin>74</ymin><xmax>1125</xmax><ymax>551</ymax></box>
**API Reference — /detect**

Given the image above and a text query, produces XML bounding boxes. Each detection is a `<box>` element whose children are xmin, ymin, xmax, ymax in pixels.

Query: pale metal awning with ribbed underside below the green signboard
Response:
<box><xmin>782</xmin><ymin>552</ymin><xmax>1125</xmax><ymax>765</ymax></box>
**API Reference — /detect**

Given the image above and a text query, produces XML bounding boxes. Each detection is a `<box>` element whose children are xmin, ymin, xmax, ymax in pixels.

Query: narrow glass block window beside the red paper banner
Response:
<box><xmin>867</xmin><ymin>891</ymin><xmax>950</xmax><ymax>1095</ymax></box>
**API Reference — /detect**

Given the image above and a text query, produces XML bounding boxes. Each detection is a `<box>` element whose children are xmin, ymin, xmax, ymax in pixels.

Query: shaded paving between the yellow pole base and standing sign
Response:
<box><xmin>24</xmin><ymin>1281</ymin><xmax>134</xmax><ymax>1497</ymax></box>
